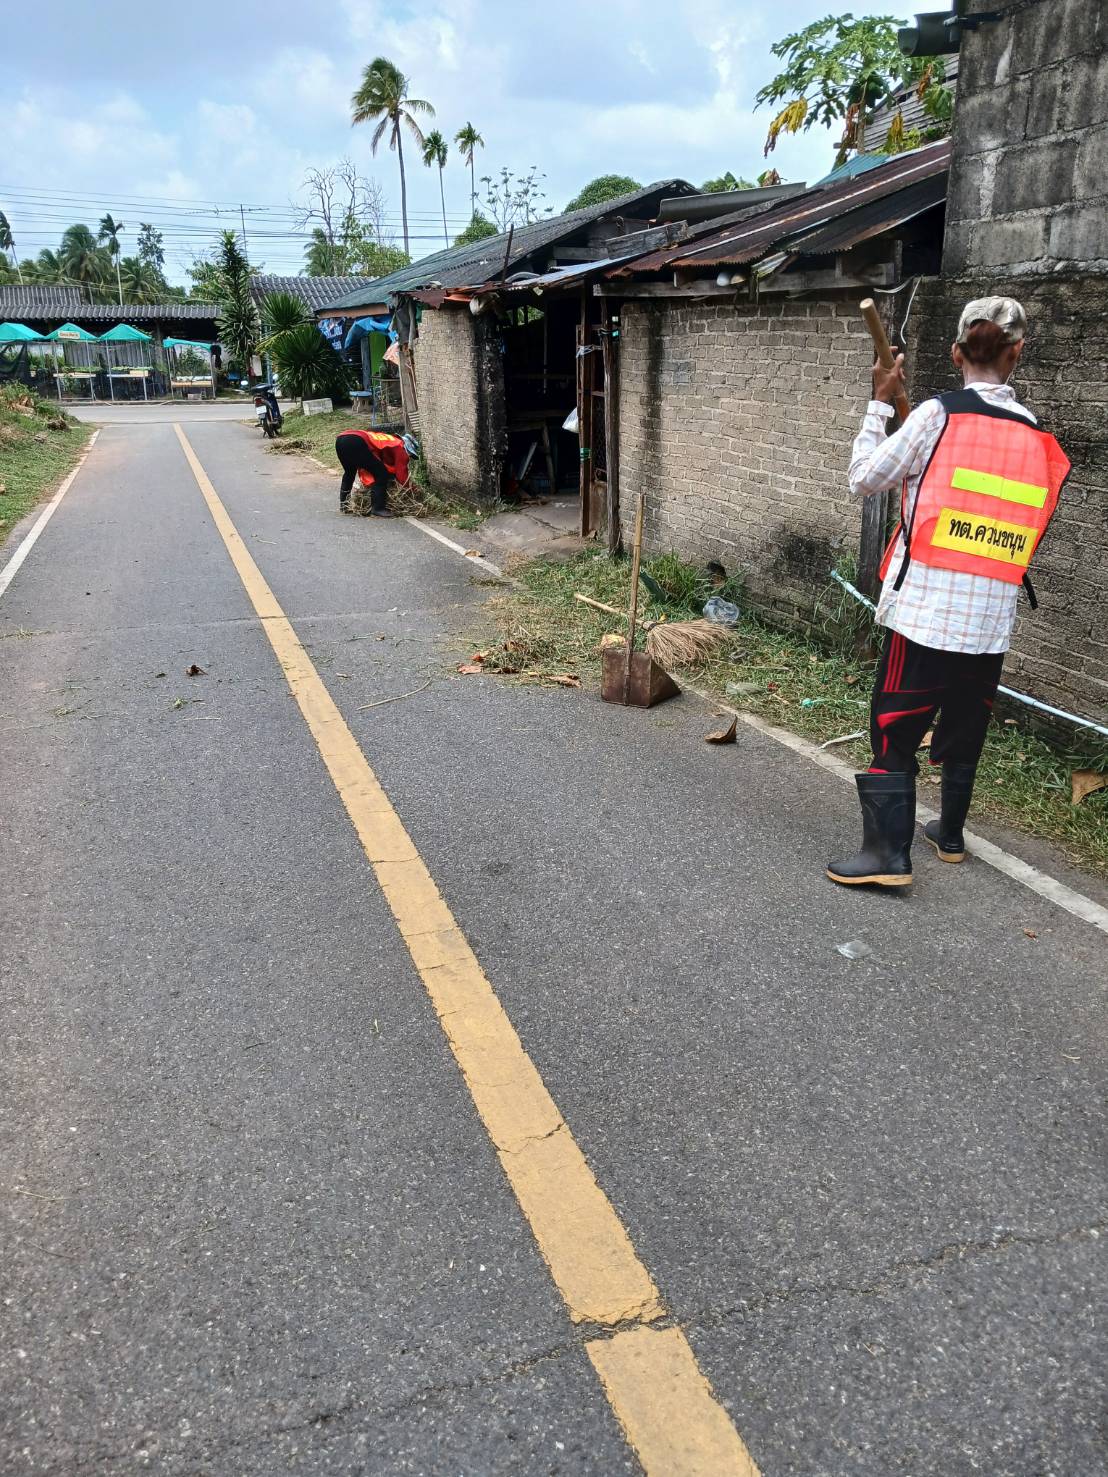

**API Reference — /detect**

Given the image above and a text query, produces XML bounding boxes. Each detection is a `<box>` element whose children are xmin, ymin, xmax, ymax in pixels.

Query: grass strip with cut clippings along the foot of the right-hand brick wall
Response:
<box><xmin>480</xmin><ymin>552</ymin><xmax>1108</xmax><ymax>876</ymax></box>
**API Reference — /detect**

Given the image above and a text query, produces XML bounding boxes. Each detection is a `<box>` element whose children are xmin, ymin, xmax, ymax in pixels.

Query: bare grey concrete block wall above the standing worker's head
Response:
<box><xmin>943</xmin><ymin>0</ymin><xmax>1108</xmax><ymax>278</ymax></box>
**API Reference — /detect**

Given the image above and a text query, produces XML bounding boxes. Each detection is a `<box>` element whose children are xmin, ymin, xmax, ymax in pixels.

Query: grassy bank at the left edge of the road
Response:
<box><xmin>0</xmin><ymin>384</ymin><xmax>89</xmax><ymax>544</ymax></box>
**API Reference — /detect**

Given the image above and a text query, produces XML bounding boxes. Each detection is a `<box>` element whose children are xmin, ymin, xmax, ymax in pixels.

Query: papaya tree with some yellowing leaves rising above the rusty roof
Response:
<box><xmin>755</xmin><ymin>15</ymin><xmax>950</xmax><ymax>164</ymax></box>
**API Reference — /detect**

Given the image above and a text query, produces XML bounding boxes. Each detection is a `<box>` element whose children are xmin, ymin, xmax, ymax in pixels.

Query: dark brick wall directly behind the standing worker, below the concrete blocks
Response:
<box><xmin>909</xmin><ymin>273</ymin><xmax>1108</xmax><ymax>722</ymax></box>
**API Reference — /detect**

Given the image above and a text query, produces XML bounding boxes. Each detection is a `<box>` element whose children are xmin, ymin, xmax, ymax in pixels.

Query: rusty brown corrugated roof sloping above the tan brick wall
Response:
<box><xmin>612</xmin><ymin>139</ymin><xmax>950</xmax><ymax>276</ymax></box>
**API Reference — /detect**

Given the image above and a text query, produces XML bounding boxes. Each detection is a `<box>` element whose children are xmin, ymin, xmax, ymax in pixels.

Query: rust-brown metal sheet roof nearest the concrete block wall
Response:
<box><xmin>609</xmin><ymin>139</ymin><xmax>950</xmax><ymax>278</ymax></box>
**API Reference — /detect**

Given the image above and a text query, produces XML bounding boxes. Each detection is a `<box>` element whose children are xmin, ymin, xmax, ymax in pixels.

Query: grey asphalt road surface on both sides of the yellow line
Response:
<box><xmin>0</xmin><ymin>419</ymin><xmax>1108</xmax><ymax>1477</ymax></box>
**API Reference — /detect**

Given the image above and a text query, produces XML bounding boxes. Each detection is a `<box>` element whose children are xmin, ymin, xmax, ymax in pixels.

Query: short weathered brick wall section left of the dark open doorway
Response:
<box><xmin>415</xmin><ymin>304</ymin><xmax>505</xmax><ymax>501</ymax></box>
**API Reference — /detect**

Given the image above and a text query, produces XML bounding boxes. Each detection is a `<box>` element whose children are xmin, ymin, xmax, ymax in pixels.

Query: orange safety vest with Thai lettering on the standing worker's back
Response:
<box><xmin>880</xmin><ymin>390</ymin><xmax>1070</xmax><ymax>595</ymax></box>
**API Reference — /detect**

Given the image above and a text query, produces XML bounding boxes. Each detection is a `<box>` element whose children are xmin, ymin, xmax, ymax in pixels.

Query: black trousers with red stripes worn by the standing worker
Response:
<box><xmin>870</xmin><ymin>631</ymin><xmax>1005</xmax><ymax>774</ymax></box>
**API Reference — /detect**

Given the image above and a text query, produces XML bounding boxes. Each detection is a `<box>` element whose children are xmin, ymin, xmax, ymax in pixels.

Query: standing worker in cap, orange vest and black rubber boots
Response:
<box><xmin>827</xmin><ymin>297</ymin><xmax>1070</xmax><ymax>888</ymax></box>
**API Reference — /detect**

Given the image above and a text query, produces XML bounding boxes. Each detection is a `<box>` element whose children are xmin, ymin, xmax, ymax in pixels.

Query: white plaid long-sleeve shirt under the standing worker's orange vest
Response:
<box><xmin>849</xmin><ymin>384</ymin><xmax>1036</xmax><ymax>654</ymax></box>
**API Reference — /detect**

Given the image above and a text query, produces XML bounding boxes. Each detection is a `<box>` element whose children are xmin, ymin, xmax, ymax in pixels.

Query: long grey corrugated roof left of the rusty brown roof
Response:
<box><xmin>319</xmin><ymin>180</ymin><xmax>696</xmax><ymax>312</ymax></box>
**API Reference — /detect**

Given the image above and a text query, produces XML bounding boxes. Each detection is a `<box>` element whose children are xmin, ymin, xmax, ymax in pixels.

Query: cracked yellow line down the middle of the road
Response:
<box><xmin>173</xmin><ymin>424</ymin><xmax>758</xmax><ymax>1477</ymax></box>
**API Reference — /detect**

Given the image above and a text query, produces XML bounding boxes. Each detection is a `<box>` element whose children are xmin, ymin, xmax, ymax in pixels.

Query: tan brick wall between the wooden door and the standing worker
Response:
<box><xmin>619</xmin><ymin>298</ymin><xmax>873</xmax><ymax>625</ymax></box>
